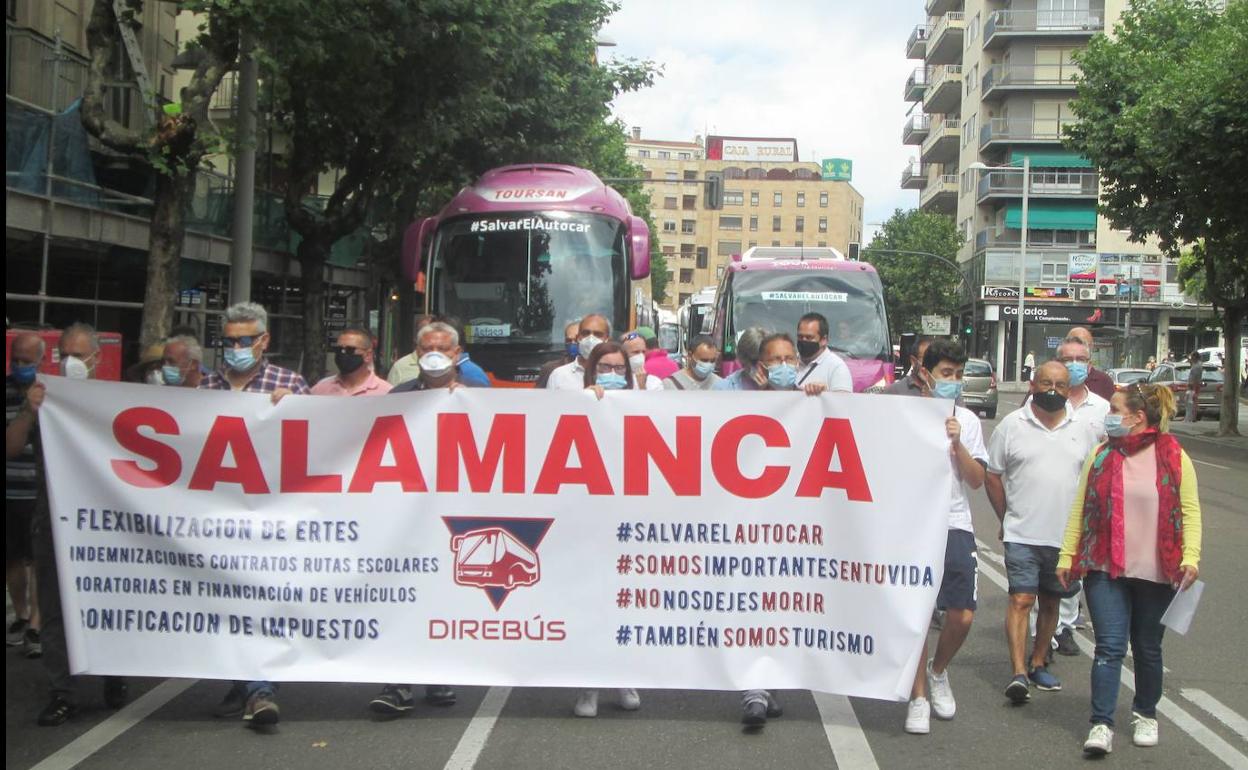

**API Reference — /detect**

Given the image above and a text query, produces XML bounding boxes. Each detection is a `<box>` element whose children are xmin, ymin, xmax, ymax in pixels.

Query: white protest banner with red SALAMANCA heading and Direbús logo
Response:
<box><xmin>40</xmin><ymin>377</ymin><xmax>952</xmax><ymax>699</ymax></box>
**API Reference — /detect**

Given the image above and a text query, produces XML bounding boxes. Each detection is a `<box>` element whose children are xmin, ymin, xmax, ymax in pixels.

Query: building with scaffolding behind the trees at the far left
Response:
<box><xmin>5</xmin><ymin>0</ymin><xmax>369</xmax><ymax>363</ymax></box>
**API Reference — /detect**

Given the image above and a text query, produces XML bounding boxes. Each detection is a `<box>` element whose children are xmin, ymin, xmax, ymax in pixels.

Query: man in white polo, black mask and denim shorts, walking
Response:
<box><xmin>985</xmin><ymin>361</ymin><xmax>1097</xmax><ymax>704</ymax></box>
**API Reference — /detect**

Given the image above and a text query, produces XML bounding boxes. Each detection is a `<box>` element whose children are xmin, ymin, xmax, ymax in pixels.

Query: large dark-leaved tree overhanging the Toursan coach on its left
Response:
<box><xmin>258</xmin><ymin>0</ymin><xmax>653</xmax><ymax>377</ymax></box>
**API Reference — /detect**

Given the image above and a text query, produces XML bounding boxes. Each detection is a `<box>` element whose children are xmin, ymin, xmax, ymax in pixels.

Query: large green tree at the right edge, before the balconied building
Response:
<box><xmin>1066</xmin><ymin>0</ymin><xmax>1248</xmax><ymax>436</ymax></box>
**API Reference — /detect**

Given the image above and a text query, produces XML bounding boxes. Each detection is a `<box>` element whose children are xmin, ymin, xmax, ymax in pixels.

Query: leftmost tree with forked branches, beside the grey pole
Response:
<box><xmin>82</xmin><ymin>0</ymin><xmax>243</xmax><ymax>347</ymax></box>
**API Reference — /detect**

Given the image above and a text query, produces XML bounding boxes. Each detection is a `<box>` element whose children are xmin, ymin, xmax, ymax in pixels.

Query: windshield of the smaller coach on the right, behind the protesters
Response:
<box><xmin>731</xmin><ymin>270</ymin><xmax>891</xmax><ymax>361</ymax></box>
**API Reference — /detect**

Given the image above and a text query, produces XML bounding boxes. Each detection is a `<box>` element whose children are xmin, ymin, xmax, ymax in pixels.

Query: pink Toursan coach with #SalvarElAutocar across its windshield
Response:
<box><xmin>403</xmin><ymin>163</ymin><xmax>650</xmax><ymax>387</ymax></box>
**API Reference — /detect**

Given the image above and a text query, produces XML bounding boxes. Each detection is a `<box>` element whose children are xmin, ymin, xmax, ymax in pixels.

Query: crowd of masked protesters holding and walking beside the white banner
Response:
<box><xmin>5</xmin><ymin>303</ymin><xmax>1201</xmax><ymax>755</ymax></box>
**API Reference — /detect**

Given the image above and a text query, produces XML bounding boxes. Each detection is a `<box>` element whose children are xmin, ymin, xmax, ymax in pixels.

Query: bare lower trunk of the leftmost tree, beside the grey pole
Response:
<box><xmin>139</xmin><ymin>171</ymin><xmax>195</xmax><ymax>348</ymax></box>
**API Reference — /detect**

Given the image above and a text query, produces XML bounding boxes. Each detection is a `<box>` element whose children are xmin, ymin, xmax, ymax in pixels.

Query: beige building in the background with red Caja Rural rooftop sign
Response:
<box><xmin>628</xmin><ymin>129</ymin><xmax>862</xmax><ymax>309</ymax></box>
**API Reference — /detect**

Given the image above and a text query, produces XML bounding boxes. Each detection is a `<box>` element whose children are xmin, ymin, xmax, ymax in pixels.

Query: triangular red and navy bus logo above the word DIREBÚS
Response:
<box><xmin>442</xmin><ymin>517</ymin><xmax>554</xmax><ymax>609</ymax></box>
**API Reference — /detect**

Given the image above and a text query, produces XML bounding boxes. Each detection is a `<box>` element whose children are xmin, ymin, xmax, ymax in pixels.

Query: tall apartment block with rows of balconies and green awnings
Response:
<box><xmin>901</xmin><ymin>0</ymin><xmax>1217</xmax><ymax>374</ymax></box>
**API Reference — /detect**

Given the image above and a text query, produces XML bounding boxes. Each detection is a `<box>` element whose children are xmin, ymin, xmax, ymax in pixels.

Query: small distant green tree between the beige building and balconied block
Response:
<box><xmin>862</xmin><ymin>208</ymin><xmax>962</xmax><ymax>333</ymax></box>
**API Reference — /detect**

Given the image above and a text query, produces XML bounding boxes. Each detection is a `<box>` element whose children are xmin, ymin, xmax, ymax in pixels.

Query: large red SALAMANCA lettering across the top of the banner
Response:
<box><xmin>110</xmin><ymin>407</ymin><xmax>872</xmax><ymax>503</ymax></box>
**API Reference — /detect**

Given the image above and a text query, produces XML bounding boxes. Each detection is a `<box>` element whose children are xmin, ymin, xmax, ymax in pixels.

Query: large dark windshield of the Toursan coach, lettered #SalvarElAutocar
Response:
<box><xmin>431</xmin><ymin>211</ymin><xmax>628</xmax><ymax>348</ymax></box>
